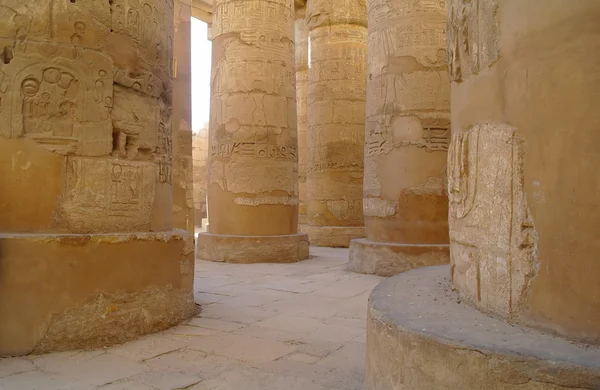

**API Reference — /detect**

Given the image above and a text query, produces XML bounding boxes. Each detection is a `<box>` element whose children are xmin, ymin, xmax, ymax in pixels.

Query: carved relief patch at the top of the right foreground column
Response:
<box><xmin>447</xmin><ymin>0</ymin><xmax>500</xmax><ymax>82</ymax></box>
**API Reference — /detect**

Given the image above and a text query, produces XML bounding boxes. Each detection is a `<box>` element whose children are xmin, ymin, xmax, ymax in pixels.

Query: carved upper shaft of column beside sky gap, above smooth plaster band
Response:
<box><xmin>209</xmin><ymin>0</ymin><xmax>298</xmax><ymax>207</ymax></box>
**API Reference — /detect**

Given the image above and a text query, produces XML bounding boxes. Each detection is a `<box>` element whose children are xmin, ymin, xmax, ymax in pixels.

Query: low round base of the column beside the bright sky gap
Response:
<box><xmin>196</xmin><ymin>233</ymin><xmax>309</xmax><ymax>264</ymax></box>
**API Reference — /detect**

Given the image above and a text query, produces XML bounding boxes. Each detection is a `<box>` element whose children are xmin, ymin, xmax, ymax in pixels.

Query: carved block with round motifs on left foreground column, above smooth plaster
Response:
<box><xmin>0</xmin><ymin>50</ymin><xmax>112</xmax><ymax>156</ymax></box>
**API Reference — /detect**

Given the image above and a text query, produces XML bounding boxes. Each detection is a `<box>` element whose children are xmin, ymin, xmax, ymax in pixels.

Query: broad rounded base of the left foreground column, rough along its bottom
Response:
<box><xmin>0</xmin><ymin>230</ymin><xmax>197</xmax><ymax>356</ymax></box>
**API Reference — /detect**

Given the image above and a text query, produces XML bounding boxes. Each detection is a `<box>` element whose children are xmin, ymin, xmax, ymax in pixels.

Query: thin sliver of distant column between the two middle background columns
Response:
<box><xmin>295</xmin><ymin>7</ymin><xmax>308</xmax><ymax>225</ymax></box>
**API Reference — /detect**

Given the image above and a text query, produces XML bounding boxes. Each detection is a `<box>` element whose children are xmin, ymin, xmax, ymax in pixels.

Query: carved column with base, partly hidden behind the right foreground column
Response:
<box><xmin>350</xmin><ymin>0</ymin><xmax>450</xmax><ymax>276</ymax></box>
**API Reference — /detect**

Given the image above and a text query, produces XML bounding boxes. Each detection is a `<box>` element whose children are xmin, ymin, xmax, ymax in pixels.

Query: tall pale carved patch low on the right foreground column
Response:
<box><xmin>448</xmin><ymin>123</ymin><xmax>536</xmax><ymax>317</ymax></box>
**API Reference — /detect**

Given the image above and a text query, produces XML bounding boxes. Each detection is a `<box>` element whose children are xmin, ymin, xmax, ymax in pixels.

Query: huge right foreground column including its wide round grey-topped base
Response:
<box><xmin>366</xmin><ymin>0</ymin><xmax>600</xmax><ymax>390</ymax></box>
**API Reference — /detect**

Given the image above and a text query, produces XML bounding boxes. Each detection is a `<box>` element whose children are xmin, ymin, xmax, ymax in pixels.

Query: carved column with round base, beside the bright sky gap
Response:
<box><xmin>198</xmin><ymin>0</ymin><xmax>308</xmax><ymax>262</ymax></box>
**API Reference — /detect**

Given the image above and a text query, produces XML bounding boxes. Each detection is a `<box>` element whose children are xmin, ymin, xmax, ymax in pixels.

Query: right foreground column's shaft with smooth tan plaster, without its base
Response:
<box><xmin>448</xmin><ymin>0</ymin><xmax>600</xmax><ymax>342</ymax></box>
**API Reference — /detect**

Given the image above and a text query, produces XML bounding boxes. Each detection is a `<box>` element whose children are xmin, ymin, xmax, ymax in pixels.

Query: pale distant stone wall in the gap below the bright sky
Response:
<box><xmin>192</xmin><ymin>129</ymin><xmax>208</xmax><ymax>222</ymax></box>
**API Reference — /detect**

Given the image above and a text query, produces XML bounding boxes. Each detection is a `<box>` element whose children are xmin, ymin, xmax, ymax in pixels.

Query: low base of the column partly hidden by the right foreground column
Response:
<box><xmin>348</xmin><ymin>238</ymin><xmax>450</xmax><ymax>276</ymax></box>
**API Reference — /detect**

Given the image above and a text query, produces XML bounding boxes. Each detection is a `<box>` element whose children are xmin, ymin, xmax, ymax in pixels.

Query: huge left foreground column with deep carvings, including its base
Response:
<box><xmin>0</xmin><ymin>0</ymin><xmax>194</xmax><ymax>355</ymax></box>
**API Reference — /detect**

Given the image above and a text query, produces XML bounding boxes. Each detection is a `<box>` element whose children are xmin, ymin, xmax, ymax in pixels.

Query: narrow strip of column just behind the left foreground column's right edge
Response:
<box><xmin>172</xmin><ymin>0</ymin><xmax>195</xmax><ymax>233</ymax></box>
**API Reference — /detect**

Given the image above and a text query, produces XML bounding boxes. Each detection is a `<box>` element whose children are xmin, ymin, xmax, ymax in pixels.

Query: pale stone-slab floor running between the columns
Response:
<box><xmin>0</xmin><ymin>248</ymin><xmax>382</xmax><ymax>390</ymax></box>
